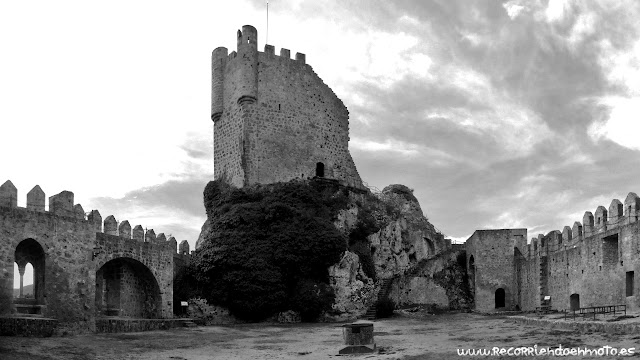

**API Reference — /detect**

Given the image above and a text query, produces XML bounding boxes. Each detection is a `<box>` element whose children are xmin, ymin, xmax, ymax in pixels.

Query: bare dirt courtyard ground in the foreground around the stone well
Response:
<box><xmin>0</xmin><ymin>313</ymin><xmax>640</xmax><ymax>360</ymax></box>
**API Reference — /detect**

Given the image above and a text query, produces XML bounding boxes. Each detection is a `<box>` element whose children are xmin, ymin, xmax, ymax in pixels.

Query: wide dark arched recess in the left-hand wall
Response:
<box><xmin>95</xmin><ymin>258</ymin><xmax>162</xmax><ymax>319</ymax></box>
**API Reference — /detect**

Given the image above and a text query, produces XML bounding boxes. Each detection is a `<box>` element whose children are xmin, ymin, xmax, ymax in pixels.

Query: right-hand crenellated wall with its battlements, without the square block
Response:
<box><xmin>521</xmin><ymin>193</ymin><xmax>640</xmax><ymax>310</ymax></box>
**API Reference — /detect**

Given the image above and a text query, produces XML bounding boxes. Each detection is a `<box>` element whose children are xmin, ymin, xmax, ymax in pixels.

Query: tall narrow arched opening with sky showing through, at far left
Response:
<box><xmin>13</xmin><ymin>239</ymin><xmax>45</xmax><ymax>314</ymax></box>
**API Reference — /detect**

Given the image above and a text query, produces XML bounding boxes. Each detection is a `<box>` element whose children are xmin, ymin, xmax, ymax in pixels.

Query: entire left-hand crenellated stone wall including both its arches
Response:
<box><xmin>0</xmin><ymin>181</ymin><xmax>176</xmax><ymax>330</ymax></box>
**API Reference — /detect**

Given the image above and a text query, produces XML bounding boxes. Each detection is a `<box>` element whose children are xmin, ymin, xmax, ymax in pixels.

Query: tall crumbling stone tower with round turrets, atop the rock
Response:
<box><xmin>211</xmin><ymin>25</ymin><xmax>362</xmax><ymax>188</ymax></box>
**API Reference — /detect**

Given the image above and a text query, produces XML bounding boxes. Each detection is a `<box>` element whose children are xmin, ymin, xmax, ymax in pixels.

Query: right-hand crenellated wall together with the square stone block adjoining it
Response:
<box><xmin>466</xmin><ymin>193</ymin><xmax>640</xmax><ymax>311</ymax></box>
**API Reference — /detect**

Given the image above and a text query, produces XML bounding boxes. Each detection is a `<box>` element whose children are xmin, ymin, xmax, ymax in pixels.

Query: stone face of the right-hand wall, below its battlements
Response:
<box><xmin>523</xmin><ymin>211</ymin><xmax>640</xmax><ymax>310</ymax></box>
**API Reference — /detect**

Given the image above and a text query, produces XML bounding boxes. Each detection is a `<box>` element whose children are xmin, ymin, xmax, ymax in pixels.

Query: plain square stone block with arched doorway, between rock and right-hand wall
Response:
<box><xmin>466</xmin><ymin>229</ymin><xmax>527</xmax><ymax>311</ymax></box>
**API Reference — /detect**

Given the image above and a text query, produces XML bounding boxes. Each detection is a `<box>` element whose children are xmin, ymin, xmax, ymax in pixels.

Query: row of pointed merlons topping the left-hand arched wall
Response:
<box><xmin>0</xmin><ymin>180</ymin><xmax>188</xmax><ymax>253</ymax></box>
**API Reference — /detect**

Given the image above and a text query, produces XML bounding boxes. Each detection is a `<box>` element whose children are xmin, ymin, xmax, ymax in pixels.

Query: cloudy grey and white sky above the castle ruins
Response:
<box><xmin>0</xmin><ymin>0</ymin><xmax>640</xmax><ymax>284</ymax></box>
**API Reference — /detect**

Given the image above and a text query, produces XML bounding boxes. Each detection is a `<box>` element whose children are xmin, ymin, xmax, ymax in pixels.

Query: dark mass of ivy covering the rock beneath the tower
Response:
<box><xmin>191</xmin><ymin>180</ymin><xmax>348</xmax><ymax>321</ymax></box>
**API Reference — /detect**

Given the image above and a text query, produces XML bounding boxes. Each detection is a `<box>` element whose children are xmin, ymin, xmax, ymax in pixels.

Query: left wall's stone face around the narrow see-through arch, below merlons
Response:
<box><xmin>0</xmin><ymin>191</ymin><xmax>95</xmax><ymax>326</ymax></box>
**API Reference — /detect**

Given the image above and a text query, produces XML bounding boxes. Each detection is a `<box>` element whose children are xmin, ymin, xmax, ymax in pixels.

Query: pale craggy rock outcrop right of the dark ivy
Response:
<box><xmin>196</xmin><ymin>180</ymin><xmax>451</xmax><ymax>321</ymax></box>
